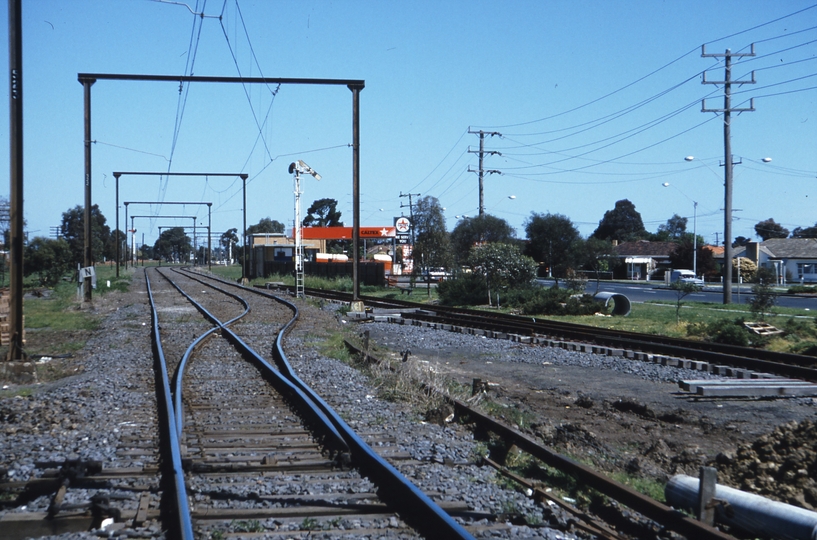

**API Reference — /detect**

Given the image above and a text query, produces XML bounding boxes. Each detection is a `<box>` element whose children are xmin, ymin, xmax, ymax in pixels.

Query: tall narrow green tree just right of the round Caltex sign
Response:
<box><xmin>412</xmin><ymin>196</ymin><xmax>452</xmax><ymax>274</ymax></box>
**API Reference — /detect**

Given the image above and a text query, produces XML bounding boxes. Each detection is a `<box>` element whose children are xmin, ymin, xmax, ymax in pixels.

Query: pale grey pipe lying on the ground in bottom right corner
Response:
<box><xmin>664</xmin><ymin>474</ymin><xmax>817</xmax><ymax>540</ymax></box>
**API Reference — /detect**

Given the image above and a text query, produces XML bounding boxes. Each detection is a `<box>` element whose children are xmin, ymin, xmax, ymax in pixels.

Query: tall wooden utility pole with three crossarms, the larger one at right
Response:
<box><xmin>701</xmin><ymin>44</ymin><xmax>755</xmax><ymax>304</ymax></box>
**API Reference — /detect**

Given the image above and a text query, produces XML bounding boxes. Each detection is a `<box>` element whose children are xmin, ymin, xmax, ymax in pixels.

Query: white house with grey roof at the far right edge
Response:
<box><xmin>734</xmin><ymin>238</ymin><xmax>817</xmax><ymax>284</ymax></box>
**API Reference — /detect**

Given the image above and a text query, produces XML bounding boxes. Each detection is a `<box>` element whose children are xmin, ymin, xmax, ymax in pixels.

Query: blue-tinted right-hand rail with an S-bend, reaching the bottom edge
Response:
<box><xmin>178</xmin><ymin>272</ymin><xmax>473</xmax><ymax>540</ymax></box>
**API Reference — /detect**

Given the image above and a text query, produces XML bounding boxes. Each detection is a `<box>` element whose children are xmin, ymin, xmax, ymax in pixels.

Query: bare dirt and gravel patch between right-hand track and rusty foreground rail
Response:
<box><xmin>360</xmin><ymin>325</ymin><xmax>817</xmax><ymax>510</ymax></box>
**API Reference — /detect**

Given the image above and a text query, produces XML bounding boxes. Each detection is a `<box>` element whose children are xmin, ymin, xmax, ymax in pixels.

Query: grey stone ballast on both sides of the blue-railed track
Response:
<box><xmin>0</xmin><ymin>272</ymin><xmax>817</xmax><ymax>539</ymax></box>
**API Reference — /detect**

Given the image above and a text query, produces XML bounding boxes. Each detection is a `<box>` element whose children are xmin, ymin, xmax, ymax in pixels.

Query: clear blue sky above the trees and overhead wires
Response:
<box><xmin>0</xmin><ymin>0</ymin><xmax>817</xmax><ymax>248</ymax></box>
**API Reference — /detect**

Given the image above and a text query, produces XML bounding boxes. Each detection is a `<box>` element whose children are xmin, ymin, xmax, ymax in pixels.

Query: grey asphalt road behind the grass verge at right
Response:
<box><xmin>537</xmin><ymin>279</ymin><xmax>817</xmax><ymax>316</ymax></box>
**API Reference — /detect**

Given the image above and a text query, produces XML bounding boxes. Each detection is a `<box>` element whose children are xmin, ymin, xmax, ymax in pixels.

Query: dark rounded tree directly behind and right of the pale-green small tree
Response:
<box><xmin>524</xmin><ymin>212</ymin><xmax>581</xmax><ymax>277</ymax></box>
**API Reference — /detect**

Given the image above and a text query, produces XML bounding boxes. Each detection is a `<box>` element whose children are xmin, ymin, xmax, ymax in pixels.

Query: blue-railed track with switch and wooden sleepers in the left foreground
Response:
<box><xmin>0</xmin><ymin>269</ymin><xmax>488</xmax><ymax>539</ymax></box>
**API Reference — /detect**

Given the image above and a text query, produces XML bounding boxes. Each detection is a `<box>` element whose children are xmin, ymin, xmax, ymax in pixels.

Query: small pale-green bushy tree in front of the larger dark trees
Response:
<box><xmin>469</xmin><ymin>243</ymin><xmax>536</xmax><ymax>306</ymax></box>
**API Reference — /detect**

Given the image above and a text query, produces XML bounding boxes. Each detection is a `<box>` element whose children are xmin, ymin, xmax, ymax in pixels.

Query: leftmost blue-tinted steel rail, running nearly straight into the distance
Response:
<box><xmin>145</xmin><ymin>269</ymin><xmax>194</xmax><ymax>540</ymax></box>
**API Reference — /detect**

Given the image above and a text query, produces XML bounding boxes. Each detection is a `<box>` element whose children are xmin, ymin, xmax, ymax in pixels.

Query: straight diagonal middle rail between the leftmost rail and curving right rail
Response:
<box><xmin>161</xmin><ymin>274</ymin><xmax>349</xmax><ymax>457</ymax></box>
